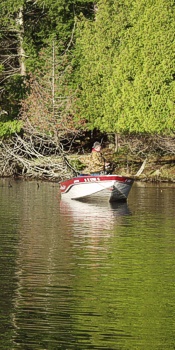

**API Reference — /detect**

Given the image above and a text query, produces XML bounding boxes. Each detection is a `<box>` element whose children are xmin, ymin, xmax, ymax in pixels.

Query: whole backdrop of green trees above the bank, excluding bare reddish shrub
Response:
<box><xmin>0</xmin><ymin>0</ymin><xmax>175</xmax><ymax>135</ymax></box>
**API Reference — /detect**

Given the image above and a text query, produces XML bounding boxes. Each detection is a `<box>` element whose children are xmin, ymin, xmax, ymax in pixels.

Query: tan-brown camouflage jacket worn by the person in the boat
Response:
<box><xmin>84</xmin><ymin>149</ymin><xmax>105</xmax><ymax>174</ymax></box>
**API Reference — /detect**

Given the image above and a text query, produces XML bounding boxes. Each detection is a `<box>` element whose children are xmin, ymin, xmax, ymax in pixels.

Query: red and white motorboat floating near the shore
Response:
<box><xmin>60</xmin><ymin>174</ymin><xmax>134</xmax><ymax>202</ymax></box>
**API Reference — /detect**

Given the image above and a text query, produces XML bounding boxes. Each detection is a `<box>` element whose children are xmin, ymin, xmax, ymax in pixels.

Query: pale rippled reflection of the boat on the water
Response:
<box><xmin>60</xmin><ymin>199</ymin><xmax>131</xmax><ymax>234</ymax></box>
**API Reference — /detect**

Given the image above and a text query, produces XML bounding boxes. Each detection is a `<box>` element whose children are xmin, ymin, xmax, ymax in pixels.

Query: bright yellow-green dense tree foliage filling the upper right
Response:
<box><xmin>76</xmin><ymin>0</ymin><xmax>175</xmax><ymax>133</ymax></box>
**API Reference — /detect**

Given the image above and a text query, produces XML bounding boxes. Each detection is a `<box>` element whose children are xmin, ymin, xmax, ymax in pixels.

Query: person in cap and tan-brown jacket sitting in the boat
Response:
<box><xmin>85</xmin><ymin>141</ymin><xmax>110</xmax><ymax>174</ymax></box>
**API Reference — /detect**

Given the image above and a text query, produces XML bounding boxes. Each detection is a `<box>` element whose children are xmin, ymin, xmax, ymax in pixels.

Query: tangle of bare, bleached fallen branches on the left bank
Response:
<box><xmin>0</xmin><ymin>134</ymin><xmax>79</xmax><ymax>180</ymax></box>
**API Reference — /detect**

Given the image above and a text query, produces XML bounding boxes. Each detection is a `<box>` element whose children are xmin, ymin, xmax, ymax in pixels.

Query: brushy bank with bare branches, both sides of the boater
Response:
<box><xmin>0</xmin><ymin>134</ymin><xmax>175</xmax><ymax>183</ymax></box>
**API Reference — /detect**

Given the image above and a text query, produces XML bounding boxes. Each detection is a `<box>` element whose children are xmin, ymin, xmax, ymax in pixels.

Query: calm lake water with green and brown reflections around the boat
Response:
<box><xmin>0</xmin><ymin>179</ymin><xmax>175</xmax><ymax>350</ymax></box>
